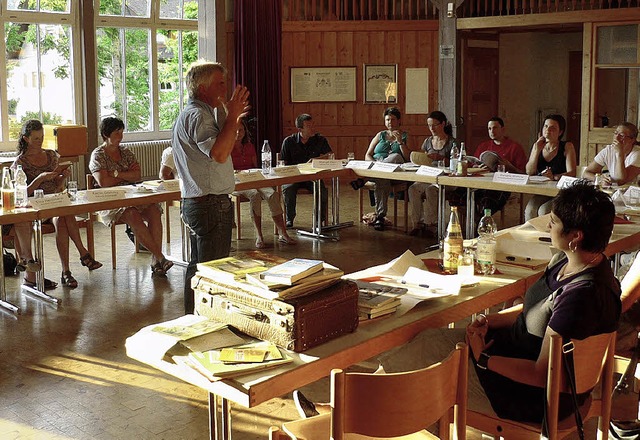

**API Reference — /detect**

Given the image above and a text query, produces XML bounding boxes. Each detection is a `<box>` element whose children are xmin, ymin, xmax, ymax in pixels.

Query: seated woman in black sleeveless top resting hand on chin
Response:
<box><xmin>524</xmin><ymin>115</ymin><xmax>576</xmax><ymax>220</ymax></box>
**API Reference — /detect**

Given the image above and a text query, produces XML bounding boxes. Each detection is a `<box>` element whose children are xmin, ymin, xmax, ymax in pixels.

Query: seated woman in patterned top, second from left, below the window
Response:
<box><xmin>89</xmin><ymin>118</ymin><xmax>173</xmax><ymax>275</ymax></box>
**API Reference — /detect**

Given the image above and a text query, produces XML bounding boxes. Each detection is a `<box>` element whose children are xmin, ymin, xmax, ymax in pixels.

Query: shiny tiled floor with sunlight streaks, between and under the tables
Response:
<box><xmin>0</xmin><ymin>185</ymin><xmax>632</xmax><ymax>440</ymax></box>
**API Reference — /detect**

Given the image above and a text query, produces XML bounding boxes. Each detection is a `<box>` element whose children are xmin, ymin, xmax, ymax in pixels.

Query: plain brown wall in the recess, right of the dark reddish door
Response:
<box><xmin>498</xmin><ymin>31</ymin><xmax>582</xmax><ymax>153</ymax></box>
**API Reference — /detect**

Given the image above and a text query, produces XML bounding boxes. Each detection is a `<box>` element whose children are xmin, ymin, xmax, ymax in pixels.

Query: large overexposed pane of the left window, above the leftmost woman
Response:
<box><xmin>5</xmin><ymin>23</ymin><xmax>76</xmax><ymax>139</ymax></box>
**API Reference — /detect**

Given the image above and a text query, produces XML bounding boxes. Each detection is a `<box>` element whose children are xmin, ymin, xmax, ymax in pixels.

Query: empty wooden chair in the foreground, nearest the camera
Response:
<box><xmin>269</xmin><ymin>343</ymin><xmax>468</xmax><ymax>440</ymax></box>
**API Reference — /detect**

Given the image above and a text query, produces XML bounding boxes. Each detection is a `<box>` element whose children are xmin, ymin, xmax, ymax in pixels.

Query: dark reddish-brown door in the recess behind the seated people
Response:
<box><xmin>463</xmin><ymin>40</ymin><xmax>499</xmax><ymax>154</ymax></box>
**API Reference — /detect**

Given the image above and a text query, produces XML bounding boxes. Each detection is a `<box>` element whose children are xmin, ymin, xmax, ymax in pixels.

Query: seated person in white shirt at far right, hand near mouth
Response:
<box><xmin>582</xmin><ymin>122</ymin><xmax>640</xmax><ymax>186</ymax></box>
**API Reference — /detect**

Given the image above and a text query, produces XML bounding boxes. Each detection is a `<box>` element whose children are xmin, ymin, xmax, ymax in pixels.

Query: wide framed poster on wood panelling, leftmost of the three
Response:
<box><xmin>291</xmin><ymin>67</ymin><xmax>356</xmax><ymax>102</ymax></box>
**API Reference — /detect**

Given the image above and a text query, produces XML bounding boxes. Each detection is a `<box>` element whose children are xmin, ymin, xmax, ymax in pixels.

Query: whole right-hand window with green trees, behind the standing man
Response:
<box><xmin>96</xmin><ymin>0</ymin><xmax>198</xmax><ymax>139</ymax></box>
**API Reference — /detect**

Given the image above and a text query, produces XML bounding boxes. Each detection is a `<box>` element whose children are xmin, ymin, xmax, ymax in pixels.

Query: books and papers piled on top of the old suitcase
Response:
<box><xmin>192</xmin><ymin>252</ymin><xmax>344</xmax><ymax>300</ymax></box>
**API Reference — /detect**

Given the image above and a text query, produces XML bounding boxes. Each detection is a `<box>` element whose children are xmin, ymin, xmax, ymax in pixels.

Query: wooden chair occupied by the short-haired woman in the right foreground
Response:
<box><xmin>467</xmin><ymin>332</ymin><xmax>616</xmax><ymax>440</ymax></box>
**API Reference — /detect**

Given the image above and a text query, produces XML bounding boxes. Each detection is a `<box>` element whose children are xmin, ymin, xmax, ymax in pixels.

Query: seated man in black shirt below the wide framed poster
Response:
<box><xmin>280</xmin><ymin>113</ymin><xmax>331</xmax><ymax>228</ymax></box>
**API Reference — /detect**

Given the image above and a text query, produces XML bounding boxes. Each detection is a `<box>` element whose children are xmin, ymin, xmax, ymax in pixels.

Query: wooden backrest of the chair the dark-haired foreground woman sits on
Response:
<box><xmin>547</xmin><ymin>332</ymin><xmax>616</xmax><ymax>438</ymax></box>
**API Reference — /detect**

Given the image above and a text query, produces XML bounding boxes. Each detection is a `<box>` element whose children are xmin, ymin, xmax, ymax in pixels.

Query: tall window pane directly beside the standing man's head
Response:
<box><xmin>156</xmin><ymin>30</ymin><xmax>198</xmax><ymax>130</ymax></box>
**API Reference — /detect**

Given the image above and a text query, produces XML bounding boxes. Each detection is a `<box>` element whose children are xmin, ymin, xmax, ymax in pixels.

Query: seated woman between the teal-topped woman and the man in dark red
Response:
<box><xmin>409</xmin><ymin>111</ymin><xmax>456</xmax><ymax>235</ymax></box>
